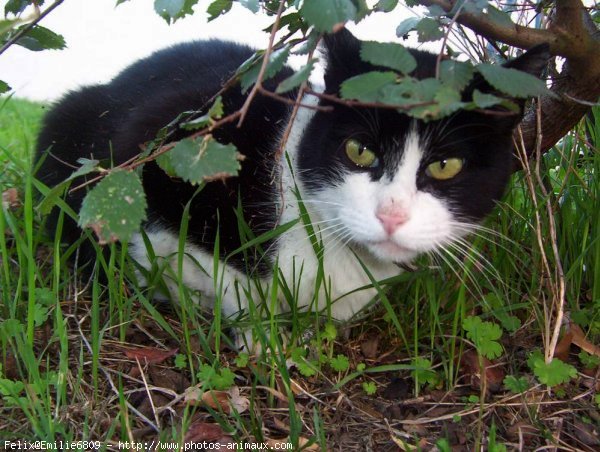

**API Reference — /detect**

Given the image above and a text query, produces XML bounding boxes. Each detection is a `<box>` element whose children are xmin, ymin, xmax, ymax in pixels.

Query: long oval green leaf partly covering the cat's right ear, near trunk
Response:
<box><xmin>477</xmin><ymin>63</ymin><xmax>550</xmax><ymax>98</ymax></box>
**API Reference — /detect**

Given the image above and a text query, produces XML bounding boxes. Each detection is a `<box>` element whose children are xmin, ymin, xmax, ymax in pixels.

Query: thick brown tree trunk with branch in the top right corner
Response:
<box><xmin>417</xmin><ymin>0</ymin><xmax>600</xmax><ymax>164</ymax></box>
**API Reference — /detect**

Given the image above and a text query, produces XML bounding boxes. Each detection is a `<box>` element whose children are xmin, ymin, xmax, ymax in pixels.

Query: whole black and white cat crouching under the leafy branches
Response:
<box><xmin>38</xmin><ymin>30</ymin><xmax>548</xmax><ymax>328</ymax></box>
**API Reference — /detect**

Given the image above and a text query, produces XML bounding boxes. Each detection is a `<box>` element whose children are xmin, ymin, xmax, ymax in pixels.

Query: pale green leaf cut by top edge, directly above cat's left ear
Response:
<box><xmin>300</xmin><ymin>0</ymin><xmax>358</xmax><ymax>33</ymax></box>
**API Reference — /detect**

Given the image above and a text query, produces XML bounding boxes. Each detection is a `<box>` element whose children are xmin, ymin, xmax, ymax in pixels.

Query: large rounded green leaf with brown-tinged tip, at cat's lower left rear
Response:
<box><xmin>79</xmin><ymin>170</ymin><xmax>147</xmax><ymax>244</ymax></box>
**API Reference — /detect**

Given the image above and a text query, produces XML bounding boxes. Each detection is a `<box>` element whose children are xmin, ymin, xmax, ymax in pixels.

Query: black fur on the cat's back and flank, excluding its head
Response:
<box><xmin>37</xmin><ymin>40</ymin><xmax>292</xmax><ymax>271</ymax></box>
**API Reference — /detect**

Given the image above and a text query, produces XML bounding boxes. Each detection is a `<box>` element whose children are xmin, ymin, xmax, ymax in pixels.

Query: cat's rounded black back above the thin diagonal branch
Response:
<box><xmin>37</xmin><ymin>40</ymin><xmax>254</xmax><ymax>185</ymax></box>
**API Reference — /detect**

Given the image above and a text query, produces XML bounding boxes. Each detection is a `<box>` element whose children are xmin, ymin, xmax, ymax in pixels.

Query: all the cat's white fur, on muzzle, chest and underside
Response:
<box><xmin>129</xmin><ymin>92</ymin><xmax>453</xmax><ymax>321</ymax></box>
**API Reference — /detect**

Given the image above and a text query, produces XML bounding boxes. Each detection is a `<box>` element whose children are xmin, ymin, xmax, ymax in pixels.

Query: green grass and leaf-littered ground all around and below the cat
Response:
<box><xmin>0</xmin><ymin>99</ymin><xmax>600</xmax><ymax>450</ymax></box>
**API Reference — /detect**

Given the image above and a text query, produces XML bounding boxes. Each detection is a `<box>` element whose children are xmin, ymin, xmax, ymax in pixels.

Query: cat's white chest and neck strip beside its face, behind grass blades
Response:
<box><xmin>277</xmin><ymin>101</ymin><xmax>400</xmax><ymax>321</ymax></box>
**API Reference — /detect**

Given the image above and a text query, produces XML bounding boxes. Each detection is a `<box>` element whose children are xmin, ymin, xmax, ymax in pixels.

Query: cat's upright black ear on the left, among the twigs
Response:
<box><xmin>323</xmin><ymin>28</ymin><xmax>365</xmax><ymax>94</ymax></box>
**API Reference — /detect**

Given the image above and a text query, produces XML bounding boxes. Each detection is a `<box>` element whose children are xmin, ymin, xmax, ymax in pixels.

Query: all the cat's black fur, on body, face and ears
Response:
<box><xmin>37</xmin><ymin>30</ymin><xmax>547</xmax><ymax>278</ymax></box>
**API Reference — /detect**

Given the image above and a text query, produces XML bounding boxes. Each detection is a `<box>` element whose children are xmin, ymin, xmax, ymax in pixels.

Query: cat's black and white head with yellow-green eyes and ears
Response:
<box><xmin>298</xmin><ymin>30</ymin><xmax>549</xmax><ymax>262</ymax></box>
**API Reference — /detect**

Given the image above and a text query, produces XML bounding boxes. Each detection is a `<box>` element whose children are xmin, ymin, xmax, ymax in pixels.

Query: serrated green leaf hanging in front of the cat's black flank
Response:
<box><xmin>168</xmin><ymin>135</ymin><xmax>241</xmax><ymax>184</ymax></box>
